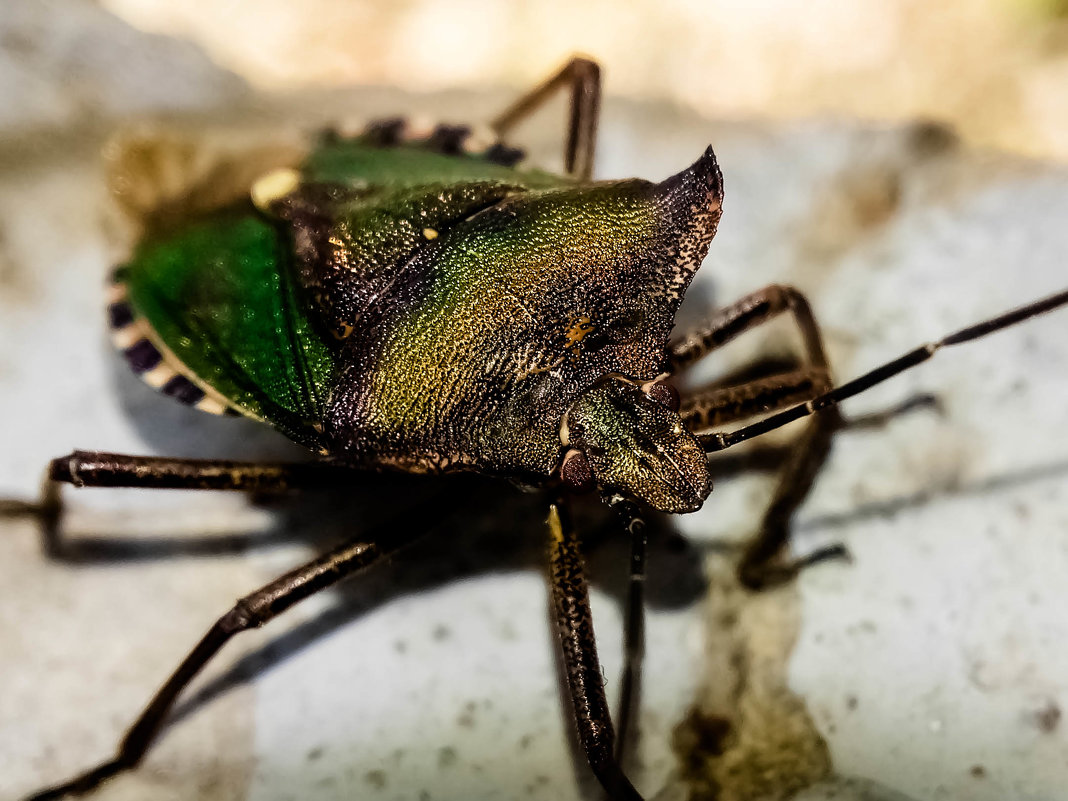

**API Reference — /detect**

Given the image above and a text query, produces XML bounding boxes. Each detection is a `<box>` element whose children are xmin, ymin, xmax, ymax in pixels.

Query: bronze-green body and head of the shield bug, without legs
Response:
<box><xmin>112</xmin><ymin>126</ymin><xmax>722</xmax><ymax>512</ymax></box>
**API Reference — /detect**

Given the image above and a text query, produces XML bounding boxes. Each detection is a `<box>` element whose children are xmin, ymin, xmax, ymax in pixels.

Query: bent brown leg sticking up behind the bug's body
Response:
<box><xmin>490</xmin><ymin>58</ymin><xmax>600</xmax><ymax>179</ymax></box>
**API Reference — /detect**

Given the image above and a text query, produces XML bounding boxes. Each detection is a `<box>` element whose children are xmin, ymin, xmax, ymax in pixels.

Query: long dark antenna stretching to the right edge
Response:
<box><xmin>697</xmin><ymin>289</ymin><xmax>1068</xmax><ymax>453</ymax></box>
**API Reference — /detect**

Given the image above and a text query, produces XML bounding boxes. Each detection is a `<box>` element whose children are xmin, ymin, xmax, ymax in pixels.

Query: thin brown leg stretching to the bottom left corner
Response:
<box><xmin>27</xmin><ymin>523</ymin><xmax>427</xmax><ymax>801</ymax></box>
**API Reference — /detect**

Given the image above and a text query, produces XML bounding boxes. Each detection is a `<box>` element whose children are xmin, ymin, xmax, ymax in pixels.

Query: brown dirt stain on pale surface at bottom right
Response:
<box><xmin>674</xmin><ymin>556</ymin><xmax>831</xmax><ymax>801</ymax></box>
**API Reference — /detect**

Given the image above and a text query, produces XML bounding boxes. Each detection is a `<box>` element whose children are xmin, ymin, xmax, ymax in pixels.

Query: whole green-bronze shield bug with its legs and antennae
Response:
<box><xmin>14</xmin><ymin>61</ymin><xmax>1066</xmax><ymax>798</ymax></box>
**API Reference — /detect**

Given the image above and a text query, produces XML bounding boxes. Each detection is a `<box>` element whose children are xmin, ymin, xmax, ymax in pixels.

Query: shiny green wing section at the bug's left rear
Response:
<box><xmin>120</xmin><ymin>204</ymin><xmax>334</xmax><ymax>445</ymax></box>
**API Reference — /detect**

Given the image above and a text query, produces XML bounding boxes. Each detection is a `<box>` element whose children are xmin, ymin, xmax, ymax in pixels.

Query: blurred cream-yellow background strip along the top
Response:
<box><xmin>101</xmin><ymin>0</ymin><xmax>1068</xmax><ymax>160</ymax></box>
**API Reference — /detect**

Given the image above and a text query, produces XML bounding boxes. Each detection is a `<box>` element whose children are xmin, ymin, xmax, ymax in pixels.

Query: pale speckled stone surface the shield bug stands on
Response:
<box><xmin>0</xmin><ymin>3</ymin><xmax>1068</xmax><ymax>801</ymax></box>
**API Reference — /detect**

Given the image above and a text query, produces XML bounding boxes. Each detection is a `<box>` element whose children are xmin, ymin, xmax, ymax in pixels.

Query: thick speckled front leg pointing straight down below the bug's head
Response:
<box><xmin>549</xmin><ymin>503</ymin><xmax>642</xmax><ymax>801</ymax></box>
